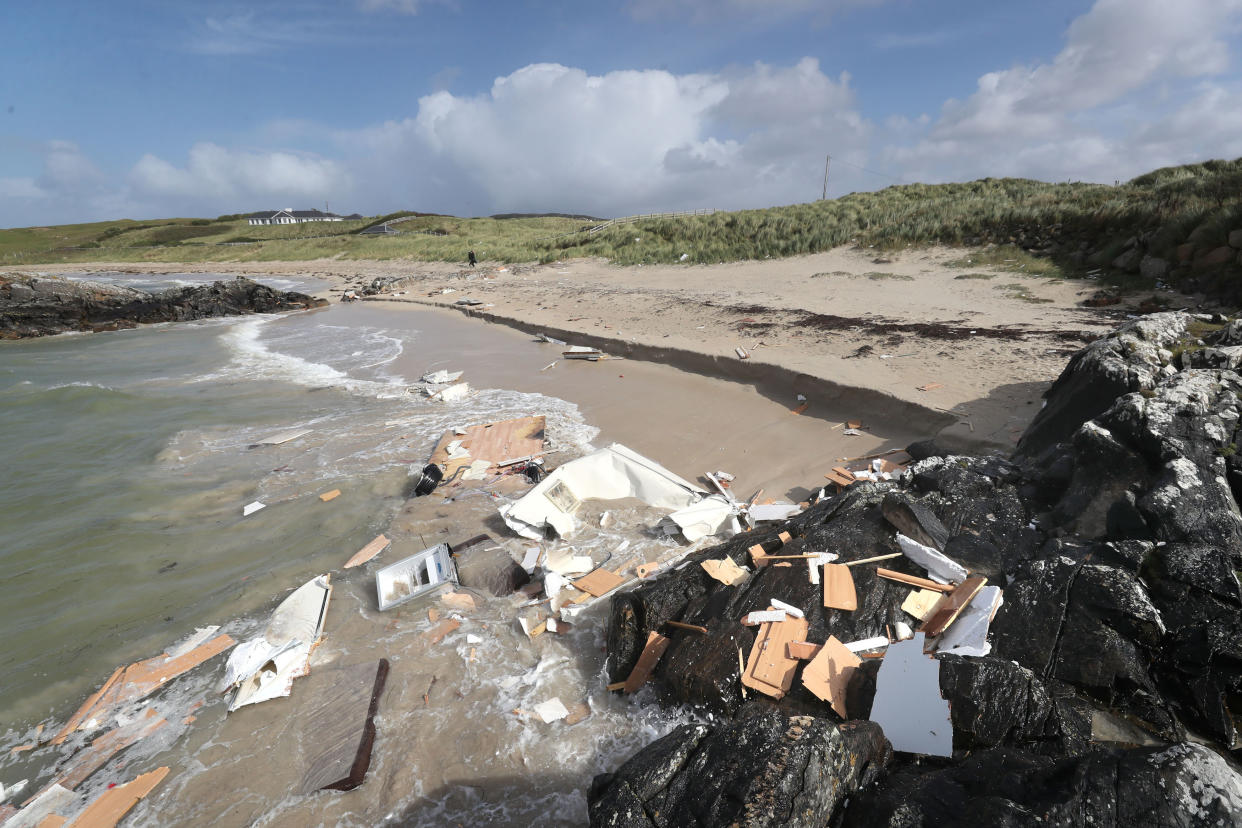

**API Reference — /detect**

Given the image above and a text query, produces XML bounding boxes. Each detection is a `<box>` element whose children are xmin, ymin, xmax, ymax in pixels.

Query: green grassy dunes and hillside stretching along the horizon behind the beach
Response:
<box><xmin>7</xmin><ymin>159</ymin><xmax>1242</xmax><ymax>296</ymax></box>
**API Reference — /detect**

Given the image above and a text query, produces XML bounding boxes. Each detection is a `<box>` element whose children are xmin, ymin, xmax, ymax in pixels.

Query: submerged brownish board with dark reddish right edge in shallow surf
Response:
<box><xmin>298</xmin><ymin>658</ymin><xmax>389</xmax><ymax>796</ymax></box>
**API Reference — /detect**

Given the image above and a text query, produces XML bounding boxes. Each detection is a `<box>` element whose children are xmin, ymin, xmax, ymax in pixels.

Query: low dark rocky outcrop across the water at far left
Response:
<box><xmin>0</xmin><ymin>274</ymin><xmax>328</xmax><ymax>339</ymax></box>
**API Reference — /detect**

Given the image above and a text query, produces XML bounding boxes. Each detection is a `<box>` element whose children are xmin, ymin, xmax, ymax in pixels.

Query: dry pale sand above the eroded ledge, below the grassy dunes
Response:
<box><xmin>14</xmin><ymin>247</ymin><xmax>1142</xmax><ymax>451</ymax></box>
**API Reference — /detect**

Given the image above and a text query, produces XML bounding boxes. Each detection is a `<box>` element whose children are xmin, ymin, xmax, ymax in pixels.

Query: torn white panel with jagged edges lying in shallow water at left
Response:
<box><xmin>221</xmin><ymin>575</ymin><xmax>332</xmax><ymax>713</ymax></box>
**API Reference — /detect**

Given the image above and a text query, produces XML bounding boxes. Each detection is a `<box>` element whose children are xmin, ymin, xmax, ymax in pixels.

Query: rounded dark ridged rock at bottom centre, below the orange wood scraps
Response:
<box><xmin>589</xmin><ymin>709</ymin><xmax>892</xmax><ymax>828</ymax></box>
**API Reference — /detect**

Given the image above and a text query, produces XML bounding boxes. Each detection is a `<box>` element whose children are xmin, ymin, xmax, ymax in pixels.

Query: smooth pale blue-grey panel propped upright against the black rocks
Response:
<box><xmin>871</xmin><ymin>633</ymin><xmax>953</xmax><ymax>756</ymax></box>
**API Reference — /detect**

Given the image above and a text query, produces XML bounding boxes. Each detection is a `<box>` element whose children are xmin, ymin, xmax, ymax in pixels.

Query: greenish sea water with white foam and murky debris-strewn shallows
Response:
<box><xmin>0</xmin><ymin>274</ymin><xmax>689</xmax><ymax>824</ymax></box>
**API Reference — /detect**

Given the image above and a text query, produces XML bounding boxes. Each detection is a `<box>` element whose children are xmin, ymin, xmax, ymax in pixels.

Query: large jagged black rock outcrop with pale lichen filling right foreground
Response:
<box><xmin>591</xmin><ymin>314</ymin><xmax>1242</xmax><ymax>826</ymax></box>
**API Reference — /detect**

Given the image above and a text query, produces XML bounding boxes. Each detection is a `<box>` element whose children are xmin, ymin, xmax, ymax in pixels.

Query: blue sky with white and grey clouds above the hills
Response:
<box><xmin>0</xmin><ymin>0</ymin><xmax>1242</xmax><ymax>227</ymax></box>
